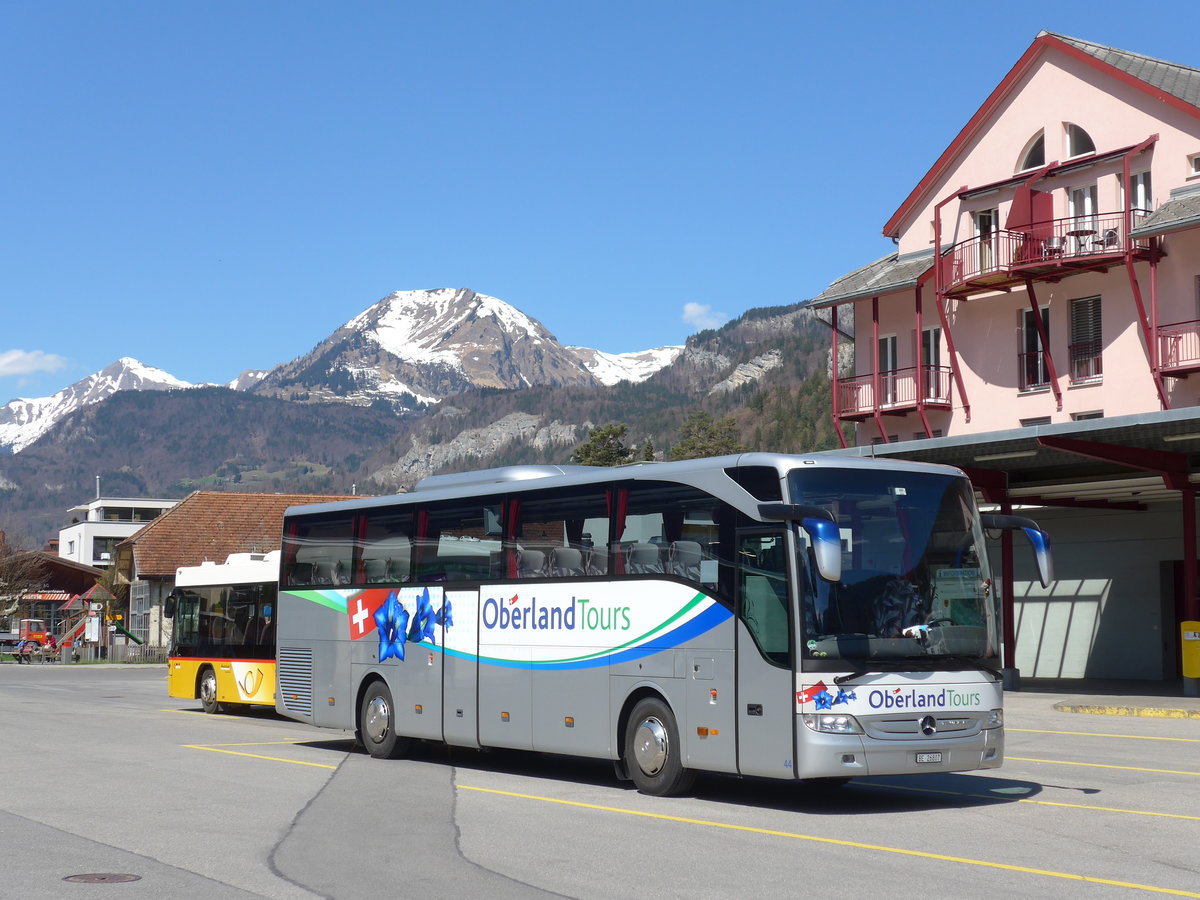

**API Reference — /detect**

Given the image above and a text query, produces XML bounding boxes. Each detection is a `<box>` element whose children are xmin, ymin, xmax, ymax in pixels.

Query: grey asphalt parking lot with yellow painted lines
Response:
<box><xmin>0</xmin><ymin>664</ymin><xmax>1200</xmax><ymax>899</ymax></box>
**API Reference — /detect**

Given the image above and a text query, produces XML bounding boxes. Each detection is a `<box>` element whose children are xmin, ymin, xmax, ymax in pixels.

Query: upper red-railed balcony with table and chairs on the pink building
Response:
<box><xmin>941</xmin><ymin>210</ymin><xmax>1150</xmax><ymax>296</ymax></box>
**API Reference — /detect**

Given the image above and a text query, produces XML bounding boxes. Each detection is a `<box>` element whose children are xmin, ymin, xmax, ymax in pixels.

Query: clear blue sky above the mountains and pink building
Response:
<box><xmin>0</xmin><ymin>0</ymin><xmax>1200</xmax><ymax>403</ymax></box>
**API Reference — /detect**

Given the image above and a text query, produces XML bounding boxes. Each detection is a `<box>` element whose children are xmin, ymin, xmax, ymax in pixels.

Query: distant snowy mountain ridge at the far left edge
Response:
<box><xmin>0</xmin><ymin>356</ymin><xmax>192</xmax><ymax>454</ymax></box>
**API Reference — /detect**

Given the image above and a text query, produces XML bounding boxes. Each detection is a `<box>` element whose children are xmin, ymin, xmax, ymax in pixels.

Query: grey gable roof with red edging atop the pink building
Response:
<box><xmin>883</xmin><ymin>31</ymin><xmax>1200</xmax><ymax>238</ymax></box>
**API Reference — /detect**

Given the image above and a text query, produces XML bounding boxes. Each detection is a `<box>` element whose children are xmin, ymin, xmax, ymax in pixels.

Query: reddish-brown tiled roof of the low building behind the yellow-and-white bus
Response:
<box><xmin>116</xmin><ymin>491</ymin><xmax>354</xmax><ymax>578</ymax></box>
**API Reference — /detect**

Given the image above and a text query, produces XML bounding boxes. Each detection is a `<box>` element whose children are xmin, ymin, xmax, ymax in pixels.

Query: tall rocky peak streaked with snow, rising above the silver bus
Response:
<box><xmin>252</xmin><ymin>288</ymin><xmax>596</xmax><ymax>409</ymax></box>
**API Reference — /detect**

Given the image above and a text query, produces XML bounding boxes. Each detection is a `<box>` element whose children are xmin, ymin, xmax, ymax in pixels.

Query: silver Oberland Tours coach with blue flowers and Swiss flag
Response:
<box><xmin>276</xmin><ymin>454</ymin><xmax>1049</xmax><ymax>794</ymax></box>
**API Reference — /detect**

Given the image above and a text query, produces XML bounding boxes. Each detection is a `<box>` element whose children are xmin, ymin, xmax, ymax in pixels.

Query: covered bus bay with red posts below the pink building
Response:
<box><xmin>833</xmin><ymin>408</ymin><xmax>1200</xmax><ymax>695</ymax></box>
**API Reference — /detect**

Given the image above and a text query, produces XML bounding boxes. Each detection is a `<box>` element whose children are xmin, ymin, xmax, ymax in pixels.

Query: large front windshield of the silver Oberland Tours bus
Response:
<box><xmin>788</xmin><ymin>467</ymin><xmax>1000</xmax><ymax>670</ymax></box>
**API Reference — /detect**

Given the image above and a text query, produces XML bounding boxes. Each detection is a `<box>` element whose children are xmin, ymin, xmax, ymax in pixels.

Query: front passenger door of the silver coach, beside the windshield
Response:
<box><xmin>737</xmin><ymin>528</ymin><xmax>796</xmax><ymax>778</ymax></box>
